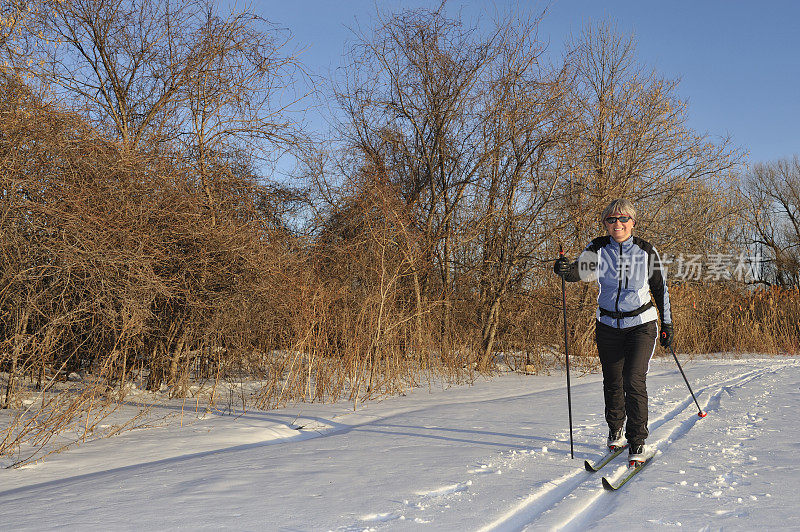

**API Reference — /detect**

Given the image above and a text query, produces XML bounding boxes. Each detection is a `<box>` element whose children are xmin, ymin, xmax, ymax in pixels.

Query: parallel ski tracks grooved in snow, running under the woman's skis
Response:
<box><xmin>480</xmin><ymin>366</ymin><xmax>783</xmax><ymax>532</ymax></box>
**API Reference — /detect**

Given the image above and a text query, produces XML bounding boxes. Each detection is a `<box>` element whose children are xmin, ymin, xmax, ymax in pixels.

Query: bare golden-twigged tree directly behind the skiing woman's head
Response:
<box><xmin>566</xmin><ymin>23</ymin><xmax>742</xmax><ymax>249</ymax></box>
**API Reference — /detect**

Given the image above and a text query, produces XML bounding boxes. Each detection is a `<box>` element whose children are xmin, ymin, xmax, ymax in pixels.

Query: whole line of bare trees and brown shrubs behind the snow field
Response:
<box><xmin>0</xmin><ymin>0</ymin><xmax>799</xmax><ymax>454</ymax></box>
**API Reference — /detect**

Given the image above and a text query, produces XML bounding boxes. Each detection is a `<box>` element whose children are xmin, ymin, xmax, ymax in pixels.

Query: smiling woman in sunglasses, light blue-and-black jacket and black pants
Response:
<box><xmin>553</xmin><ymin>198</ymin><xmax>674</xmax><ymax>465</ymax></box>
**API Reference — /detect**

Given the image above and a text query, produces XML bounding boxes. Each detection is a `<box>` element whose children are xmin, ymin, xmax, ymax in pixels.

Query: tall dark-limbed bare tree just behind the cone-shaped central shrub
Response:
<box><xmin>337</xmin><ymin>11</ymin><xmax>504</xmax><ymax>350</ymax></box>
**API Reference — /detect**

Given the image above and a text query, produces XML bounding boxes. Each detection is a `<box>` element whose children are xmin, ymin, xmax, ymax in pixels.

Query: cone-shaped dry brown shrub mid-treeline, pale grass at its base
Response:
<box><xmin>290</xmin><ymin>173</ymin><xmax>462</xmax><ymax>403</ymax></box>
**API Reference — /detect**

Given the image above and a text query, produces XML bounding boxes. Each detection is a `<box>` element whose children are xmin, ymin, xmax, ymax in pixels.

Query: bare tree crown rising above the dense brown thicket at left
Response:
<box><xmin>14</xmin><ymin>0</ymin><xmax>306</xmax><ymax>159</ymax></box>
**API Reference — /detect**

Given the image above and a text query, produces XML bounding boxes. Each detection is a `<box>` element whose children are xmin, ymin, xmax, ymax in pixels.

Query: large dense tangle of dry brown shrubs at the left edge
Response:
<box><xmin>0</xmin><ymin>71</ymin><xmax>302</xmax><ymax>458</ymax></box>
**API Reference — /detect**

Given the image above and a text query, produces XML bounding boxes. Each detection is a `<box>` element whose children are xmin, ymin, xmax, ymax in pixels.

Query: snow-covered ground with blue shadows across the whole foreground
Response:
<box><xmin>0</xmin><ymin>357</ymin><xmax>800</xmax><ymax>531</ymax></box>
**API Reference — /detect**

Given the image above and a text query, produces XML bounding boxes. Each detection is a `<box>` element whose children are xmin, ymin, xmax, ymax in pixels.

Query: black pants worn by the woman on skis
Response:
<box><xmin>595</xmin><ymin>321</ymin><xmax>658</xmax><ymax>445</ymax></box>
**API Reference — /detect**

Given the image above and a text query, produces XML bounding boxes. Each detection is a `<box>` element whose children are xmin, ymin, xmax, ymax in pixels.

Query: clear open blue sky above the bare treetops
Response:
<box><xmin>252</xmin><ymin>0</ymin><xmax>800</xmax><ymax>162</ymax></box>
